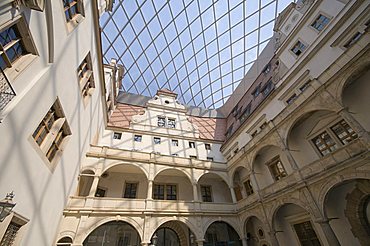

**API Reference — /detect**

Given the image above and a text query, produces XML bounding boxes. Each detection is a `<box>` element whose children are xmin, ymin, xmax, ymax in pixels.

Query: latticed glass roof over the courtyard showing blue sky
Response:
<box><xmin>100</xmin><ymin>0</ymin><xmax>292</xmax><ymax>108</ymax></box>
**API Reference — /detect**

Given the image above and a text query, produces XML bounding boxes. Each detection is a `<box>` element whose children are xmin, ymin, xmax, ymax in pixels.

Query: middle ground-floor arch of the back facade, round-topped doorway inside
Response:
<box><xmin>151</xmin><ymin>221</ymin><xmax>196</xmax><ymax>246</ymax></box>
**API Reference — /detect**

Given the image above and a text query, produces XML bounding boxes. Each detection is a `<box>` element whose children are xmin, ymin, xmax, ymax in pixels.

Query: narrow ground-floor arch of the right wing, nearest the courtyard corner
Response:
<box><xmin>245</xmin><ymin>216</ymin><xmax>269</xmax><ymax>246</ymax></box>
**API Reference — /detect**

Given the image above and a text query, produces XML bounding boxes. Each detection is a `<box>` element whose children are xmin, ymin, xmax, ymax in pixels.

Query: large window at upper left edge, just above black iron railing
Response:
<box><xmin>0</xmin><ymin>17</ymin><xmax>37</xmax><ymax>70</ymax></box>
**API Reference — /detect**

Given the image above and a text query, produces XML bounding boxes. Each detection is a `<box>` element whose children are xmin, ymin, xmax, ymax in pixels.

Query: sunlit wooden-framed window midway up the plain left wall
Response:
<box><xmin>32</xmin><ymin>99</ymin><xmax>71</xmax><ymax>162</ymax></box>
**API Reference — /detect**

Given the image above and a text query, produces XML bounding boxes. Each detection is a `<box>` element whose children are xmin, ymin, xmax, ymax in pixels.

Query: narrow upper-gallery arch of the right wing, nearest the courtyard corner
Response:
<box><xmin>233</xmin><ymin>167</ymin><xmax>253</xmax><ymax>201</ymax></box>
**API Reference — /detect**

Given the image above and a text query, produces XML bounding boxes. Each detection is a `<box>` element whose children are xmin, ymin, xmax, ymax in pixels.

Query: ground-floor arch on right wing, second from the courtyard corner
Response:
<box><xmin>273</xmin><ymin>203</ymin><xmax>323</xmax><ymax>245</ymax></box>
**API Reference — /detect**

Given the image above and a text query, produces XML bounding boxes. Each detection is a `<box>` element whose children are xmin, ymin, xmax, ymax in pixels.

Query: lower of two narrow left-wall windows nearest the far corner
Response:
<box><xmin>77</xmin><ymin>52</ymin><xmax>95</xmax><ymax>97</ymax></box>
